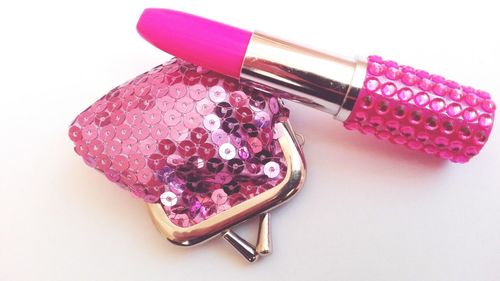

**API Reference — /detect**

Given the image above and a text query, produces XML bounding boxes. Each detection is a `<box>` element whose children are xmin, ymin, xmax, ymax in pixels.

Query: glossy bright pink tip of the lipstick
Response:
<box><xmin>137</xmin><ymin>8</ymin><xmax>252</xmax><ymax>78</ymax></box>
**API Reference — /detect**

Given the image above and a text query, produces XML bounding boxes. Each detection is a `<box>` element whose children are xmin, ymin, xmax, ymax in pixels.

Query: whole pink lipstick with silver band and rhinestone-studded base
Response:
<box><xmin>137</xmin><ymin>9</ymin><xmax>496</xmax><ymax>163</ymax></box>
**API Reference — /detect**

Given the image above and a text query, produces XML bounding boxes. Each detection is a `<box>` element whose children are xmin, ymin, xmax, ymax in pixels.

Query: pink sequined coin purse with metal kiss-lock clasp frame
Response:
<box><xmin>69</xmin><ymin>59</ymin><xmax>305</xmax><ymax>261</ymax></box>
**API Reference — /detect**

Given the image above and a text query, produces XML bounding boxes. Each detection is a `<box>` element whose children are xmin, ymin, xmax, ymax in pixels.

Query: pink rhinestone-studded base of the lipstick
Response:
<box><xmin>344</xmin><ymin>56</ymin><xmax>496</xmax><ymax>163</ymax></box>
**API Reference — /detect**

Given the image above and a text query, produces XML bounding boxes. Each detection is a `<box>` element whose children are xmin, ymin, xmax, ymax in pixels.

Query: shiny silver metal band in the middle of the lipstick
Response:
<box><xmin>241</xmin><ymin>32</ymin><xmax>367</xmax><ymax>122</ymax></box>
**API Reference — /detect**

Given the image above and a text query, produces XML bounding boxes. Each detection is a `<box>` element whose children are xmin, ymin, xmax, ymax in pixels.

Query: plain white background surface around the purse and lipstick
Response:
<box><xmin>0</xmin><ymin>0</ymin><xmax>500</xmax><ymax>281</ymax></box>
